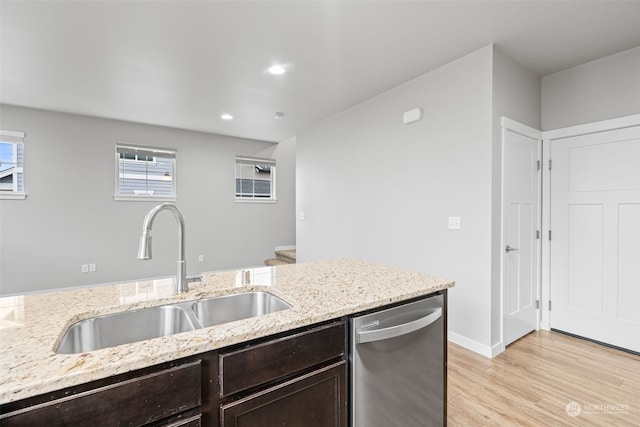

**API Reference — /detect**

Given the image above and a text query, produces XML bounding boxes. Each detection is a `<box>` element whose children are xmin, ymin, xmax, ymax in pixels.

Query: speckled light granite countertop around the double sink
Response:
<box><xmin>0</xmin><ymin>259</ymin><xmax>454</xmax><ymax>403</ymax></box>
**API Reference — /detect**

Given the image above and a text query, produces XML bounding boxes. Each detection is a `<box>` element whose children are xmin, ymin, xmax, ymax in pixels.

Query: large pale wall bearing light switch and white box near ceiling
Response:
<box><xmin>296</xmin><ymin>46</ymin><xmax>493</xmax><ymax>354</ymax></box>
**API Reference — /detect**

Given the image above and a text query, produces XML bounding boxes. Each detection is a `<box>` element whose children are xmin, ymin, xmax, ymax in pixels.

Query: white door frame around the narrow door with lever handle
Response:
<box><xmin>493</xmin><ymin>116</ymin><xmax>543</xmax><ymax>357</ymax></box>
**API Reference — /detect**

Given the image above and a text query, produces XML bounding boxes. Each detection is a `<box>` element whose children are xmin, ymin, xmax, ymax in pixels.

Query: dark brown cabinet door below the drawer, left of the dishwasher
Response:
<box><xmin>220</xmin><ymin>361</ymin><xmax>347</xmax><ymax>427</ymax></box>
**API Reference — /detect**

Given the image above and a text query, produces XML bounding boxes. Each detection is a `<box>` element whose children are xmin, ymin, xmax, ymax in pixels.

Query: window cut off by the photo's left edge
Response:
<box><xmin>0</xmin><ymin>130</ymin><xmax>26</xmax><ymax>199</ymax></box>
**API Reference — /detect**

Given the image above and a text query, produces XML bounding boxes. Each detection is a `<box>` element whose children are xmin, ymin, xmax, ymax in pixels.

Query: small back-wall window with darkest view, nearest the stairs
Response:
<box><xmin>236</xmin><ymin>156</ymin><xmax>276</xmax><ymax>201</ymax></box>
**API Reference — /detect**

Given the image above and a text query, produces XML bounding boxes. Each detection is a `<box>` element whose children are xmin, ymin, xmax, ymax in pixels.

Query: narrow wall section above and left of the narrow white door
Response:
<box><xmin>491</xmin><ymin>48</ymin><xmax>541</xmax><ymax>347</ymax></box>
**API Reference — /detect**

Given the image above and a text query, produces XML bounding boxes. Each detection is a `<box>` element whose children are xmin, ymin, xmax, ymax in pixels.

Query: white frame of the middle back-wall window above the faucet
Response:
<box><xmin>113</xmin><ymin>142</ymin><xmax>178</xmax><ymax>202</ymax></box>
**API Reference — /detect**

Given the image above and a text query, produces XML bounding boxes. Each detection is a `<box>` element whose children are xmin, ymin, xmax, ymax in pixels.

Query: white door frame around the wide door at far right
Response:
<box><xmin>540</xmin><ymin>114</ymin><xmax>640</xmax><ymax>331</ymax></box>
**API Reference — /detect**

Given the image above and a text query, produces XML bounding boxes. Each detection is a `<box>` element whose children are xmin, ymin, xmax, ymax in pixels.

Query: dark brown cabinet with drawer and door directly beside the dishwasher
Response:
<box><xmin>219</xmin><ymin>322</ymin><xmax>347</xmax><ymax>427</ymax></box>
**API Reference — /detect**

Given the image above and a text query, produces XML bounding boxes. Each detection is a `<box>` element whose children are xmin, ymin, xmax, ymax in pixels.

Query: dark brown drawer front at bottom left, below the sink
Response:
<box><xmin>0</xmin><ymin>361</ymin><xmax>202</xmax><ymax>427</ymax></box>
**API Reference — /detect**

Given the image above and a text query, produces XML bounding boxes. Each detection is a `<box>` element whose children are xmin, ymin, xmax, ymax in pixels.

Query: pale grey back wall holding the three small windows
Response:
<box><xmin>0</xmin><ymin>105</ymin><xmax>295</xmax><ymax>295</ymax></box>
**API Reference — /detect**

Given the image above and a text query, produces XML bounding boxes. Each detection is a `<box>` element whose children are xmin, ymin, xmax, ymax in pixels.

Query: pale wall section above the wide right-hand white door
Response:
<box><xmin>542</xmin><ymin>46</ymin><xmax>640</xmax><ymax>130</ymax></box>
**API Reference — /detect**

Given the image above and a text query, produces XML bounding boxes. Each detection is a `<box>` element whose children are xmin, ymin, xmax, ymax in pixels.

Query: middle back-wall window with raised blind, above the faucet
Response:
<box><xmin>115</xmin><ymin>143</ymin><xmax>176</xmax><ymax>200</ymax></box>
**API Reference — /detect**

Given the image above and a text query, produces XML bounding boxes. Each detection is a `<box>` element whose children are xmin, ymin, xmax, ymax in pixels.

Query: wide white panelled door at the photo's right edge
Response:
<box><xmin>550</xmin><ymin>126</ymin><xmax>640</xmax><ymax>351</ymax></box>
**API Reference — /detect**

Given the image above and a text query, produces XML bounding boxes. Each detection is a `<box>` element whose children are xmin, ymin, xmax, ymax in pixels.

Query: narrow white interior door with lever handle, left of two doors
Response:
<box><xmin>502</xmin><ymin>129</ymin><xmax>541</xmax><ymax>345</ymax></box>
